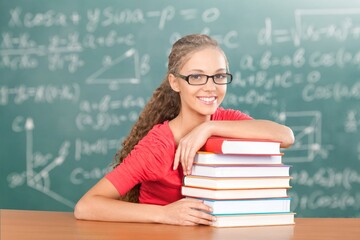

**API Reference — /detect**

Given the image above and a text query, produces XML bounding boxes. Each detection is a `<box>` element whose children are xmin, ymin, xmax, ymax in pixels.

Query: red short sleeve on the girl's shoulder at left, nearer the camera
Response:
<box><xmin>105</xmin><ymin>123</ymin><xmax>175</xmax><ymax>195</ymax></box>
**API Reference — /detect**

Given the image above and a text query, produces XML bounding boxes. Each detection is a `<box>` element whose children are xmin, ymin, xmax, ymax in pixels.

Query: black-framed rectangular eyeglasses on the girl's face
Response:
<box><xmin>175</xmin><ymin>73</ymin><xmax>232</xmax><ymax>85</ymax></box>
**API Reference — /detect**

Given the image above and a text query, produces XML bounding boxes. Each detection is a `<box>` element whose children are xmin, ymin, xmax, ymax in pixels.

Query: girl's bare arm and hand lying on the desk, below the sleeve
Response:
<box><xmin>74</xmin><ymin>178</ymin><xmax>214</xmax><ymax>225</ymax></box>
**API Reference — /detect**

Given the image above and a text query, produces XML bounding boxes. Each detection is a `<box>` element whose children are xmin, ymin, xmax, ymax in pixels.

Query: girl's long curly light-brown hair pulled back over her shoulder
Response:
<box><xmin>113</xmin><ymin>34</ymin><xmax>226</xmax><ymax>202</ymax></box>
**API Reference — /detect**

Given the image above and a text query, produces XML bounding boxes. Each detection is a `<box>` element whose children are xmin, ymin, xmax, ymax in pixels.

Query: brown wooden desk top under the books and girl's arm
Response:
<box><xmin>0</xmin><ymin>210</ymin><xmax>360</xmax><ymax>240</ymax></box>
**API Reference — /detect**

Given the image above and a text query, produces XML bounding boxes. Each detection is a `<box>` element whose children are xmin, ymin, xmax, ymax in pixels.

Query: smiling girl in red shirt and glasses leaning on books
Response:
<box><xmin>74</xmin><ymin>35</ymin><xmax>294</xmax><ymax>225</ymax></box>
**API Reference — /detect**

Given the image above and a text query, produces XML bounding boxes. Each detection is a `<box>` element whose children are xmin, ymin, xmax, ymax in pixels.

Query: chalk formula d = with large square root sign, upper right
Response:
<box><xmin>257</xmin><ymin>8</ymin><xmax>360</xmax><ymax>46</ymax></box>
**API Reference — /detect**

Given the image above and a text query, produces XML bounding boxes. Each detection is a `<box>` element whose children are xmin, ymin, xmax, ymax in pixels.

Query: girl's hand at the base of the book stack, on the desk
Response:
<box><xmin>160</xmin><ymin>198</ymin><xmax>215</xmax><ymax>226</ymax></box>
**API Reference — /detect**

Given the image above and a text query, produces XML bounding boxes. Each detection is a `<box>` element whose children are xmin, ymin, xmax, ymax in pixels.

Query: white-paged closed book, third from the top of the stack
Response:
<box><xmin>191</xmin><ymin>163</ymin><xmax>290</xmax><ymax>177</ymax></box>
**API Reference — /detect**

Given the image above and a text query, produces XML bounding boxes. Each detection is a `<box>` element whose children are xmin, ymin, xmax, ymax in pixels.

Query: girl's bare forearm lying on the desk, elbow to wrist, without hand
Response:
<box><xmin>74</xmin><ymin>196</ymin><xmax>162</xmax><ymax>223</ymax></box>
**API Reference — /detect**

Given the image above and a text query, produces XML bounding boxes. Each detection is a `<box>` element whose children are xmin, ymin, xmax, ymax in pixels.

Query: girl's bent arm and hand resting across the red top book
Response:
<box><xmin>174</xmin><ymin>120</ymin><xmax>294</xmax><ymax>175</ymax></box>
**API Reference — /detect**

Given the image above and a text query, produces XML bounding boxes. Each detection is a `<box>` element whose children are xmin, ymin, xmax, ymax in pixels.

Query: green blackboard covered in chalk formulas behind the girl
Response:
<box><xmin>0</xmin><ymin>0</ymin><xmax>360</xmax><ymax>217</ymax></box>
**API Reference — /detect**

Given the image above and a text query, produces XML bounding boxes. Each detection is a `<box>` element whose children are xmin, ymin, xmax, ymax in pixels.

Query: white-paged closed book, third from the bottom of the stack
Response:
<box><xmin>181</xmin><ymin>186</ymin><xmax>288</xmax><ymax>200</ymax></box>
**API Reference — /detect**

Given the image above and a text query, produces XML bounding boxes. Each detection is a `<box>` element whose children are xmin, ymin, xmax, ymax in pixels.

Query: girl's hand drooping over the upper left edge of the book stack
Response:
<box><xmin>173</xmin><ymin>122</ymin><xmax>211</xmax><ymax>175</ymax></box>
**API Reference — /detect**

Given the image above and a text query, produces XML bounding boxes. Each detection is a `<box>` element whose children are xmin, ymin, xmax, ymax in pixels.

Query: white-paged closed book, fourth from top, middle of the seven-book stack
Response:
<box><xmin>183</xmin><ymin>175</ymin><xmax>291</xmax><ymax>189</ymax></box>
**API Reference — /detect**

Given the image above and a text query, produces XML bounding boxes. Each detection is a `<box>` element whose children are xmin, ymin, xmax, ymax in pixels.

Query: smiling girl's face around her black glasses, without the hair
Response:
<box><xmin>170</xmin><ymin>48</ymin><xmax>227</xmax><ymax>116</ymax></box>
